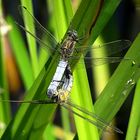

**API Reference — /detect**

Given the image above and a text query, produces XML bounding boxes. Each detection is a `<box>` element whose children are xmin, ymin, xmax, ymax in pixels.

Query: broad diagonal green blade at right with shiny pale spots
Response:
<box><xmin>94</xmin><ymin>32</ymin><xmax>140</xmax><ymax>135</ymax></box>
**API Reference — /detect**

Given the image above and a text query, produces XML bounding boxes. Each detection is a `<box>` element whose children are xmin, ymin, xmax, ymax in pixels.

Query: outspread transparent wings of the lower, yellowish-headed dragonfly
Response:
<box><xmin>0</xmin><ymin>100</ymin><xmax>123</xmax><ymax>134</ymax></box>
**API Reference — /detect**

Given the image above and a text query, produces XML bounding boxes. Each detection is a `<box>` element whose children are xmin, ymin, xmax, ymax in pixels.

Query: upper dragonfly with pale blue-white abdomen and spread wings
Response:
<box><xmin>17</xmin><ymin>6</ymin><xmax>132</xmax><ymax>99</ymax></box>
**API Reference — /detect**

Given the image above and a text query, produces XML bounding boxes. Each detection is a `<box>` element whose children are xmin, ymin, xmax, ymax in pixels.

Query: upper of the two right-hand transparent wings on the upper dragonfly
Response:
<box><xmin>74</xmin><ymin>40</ymin><xmax>131</xmax><ymax>57</ymax></box>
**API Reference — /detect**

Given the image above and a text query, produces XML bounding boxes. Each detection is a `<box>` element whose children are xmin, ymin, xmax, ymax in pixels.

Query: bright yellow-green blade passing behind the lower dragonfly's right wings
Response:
<box><xmin>71</xmin><ymin>61</ymin><xmax>99</xmax><ymax>140</ymax></box>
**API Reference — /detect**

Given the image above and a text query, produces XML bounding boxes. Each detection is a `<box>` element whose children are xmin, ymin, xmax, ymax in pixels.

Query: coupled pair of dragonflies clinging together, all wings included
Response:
<box><xmin>0</xmin><ymin>6</ymin><xmax>135</xmax><ymax>134</ymax></box>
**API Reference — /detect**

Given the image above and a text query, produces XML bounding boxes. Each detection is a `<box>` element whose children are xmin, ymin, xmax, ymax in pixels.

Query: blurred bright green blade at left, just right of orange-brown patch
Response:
<box><xmin>8</xmin><ymin>17</ymin><xmax>34</xmax><ymax>89</ymax></box>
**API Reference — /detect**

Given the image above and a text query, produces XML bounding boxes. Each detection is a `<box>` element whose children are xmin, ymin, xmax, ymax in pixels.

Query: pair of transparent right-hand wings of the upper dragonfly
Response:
<box><xmin>69</xmin><ymin>40</ymin><xmax>134</xmax><ymax>67</ymax></box>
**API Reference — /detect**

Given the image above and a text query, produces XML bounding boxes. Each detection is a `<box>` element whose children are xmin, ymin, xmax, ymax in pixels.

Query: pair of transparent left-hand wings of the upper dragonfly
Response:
<box><xmin>16</xmin><ymin>6</ymin><xmax>58</xmax><ymax>52</ymax></box>
